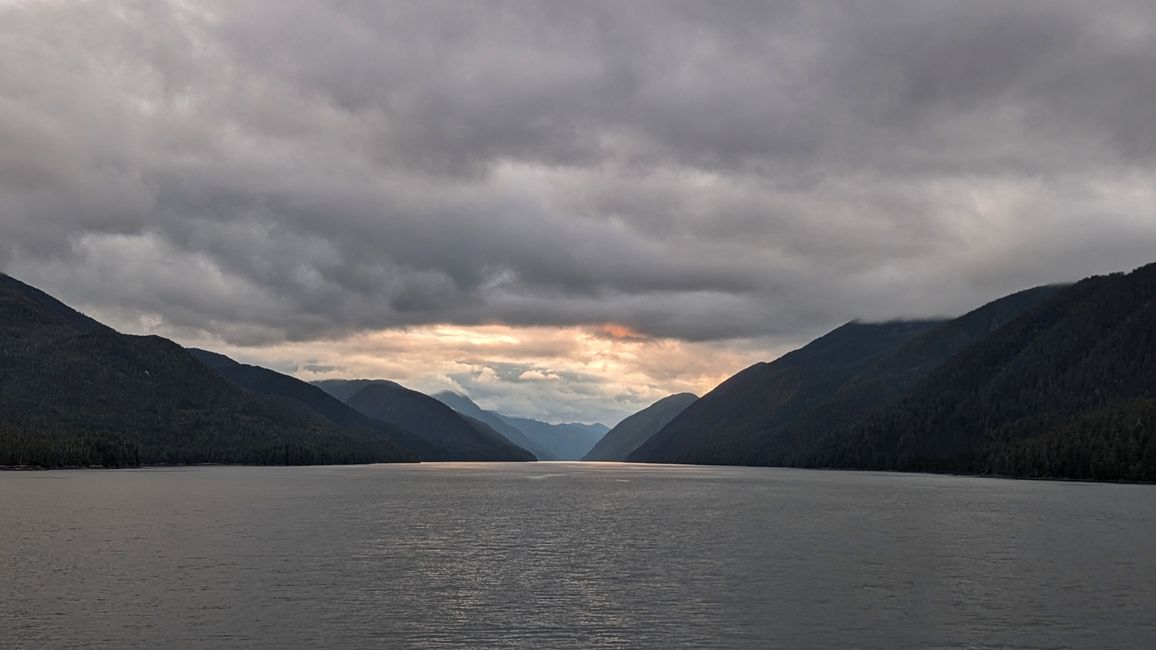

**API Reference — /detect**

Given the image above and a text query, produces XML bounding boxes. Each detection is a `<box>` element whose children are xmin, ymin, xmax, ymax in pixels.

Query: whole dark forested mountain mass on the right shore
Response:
<box><xmin>628</xmin><ymin>265</ymin><xmax>1156</xmax><ymax>480</ymax></box>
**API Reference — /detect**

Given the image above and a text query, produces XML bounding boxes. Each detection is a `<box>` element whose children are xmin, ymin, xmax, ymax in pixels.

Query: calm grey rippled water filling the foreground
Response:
<box><xmin>0</xmin><ymin>463</ymin><xmax>1156</xmax><ymax>649</ymax></box>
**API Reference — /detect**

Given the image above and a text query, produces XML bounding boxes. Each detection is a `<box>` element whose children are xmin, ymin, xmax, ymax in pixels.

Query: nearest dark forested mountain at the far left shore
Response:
<box><xmin>0</xmin><ymin>274</ymin><xmax>410</xmax><ymax>467</ymax></box>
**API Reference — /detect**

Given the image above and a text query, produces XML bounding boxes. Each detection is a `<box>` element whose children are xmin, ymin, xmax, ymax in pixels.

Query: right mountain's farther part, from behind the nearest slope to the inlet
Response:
<box><xmin>630</xmin><ymin>287</ymin><xmax>1061</xmax><ymax>465</ymax></box>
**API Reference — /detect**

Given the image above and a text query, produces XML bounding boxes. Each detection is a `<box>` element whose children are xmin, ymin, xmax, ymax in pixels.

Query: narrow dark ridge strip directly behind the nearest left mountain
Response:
<box><xmin>187</xmin><ymin>348</ymin><xmax>445</xmax><ymax>459</ymax></box>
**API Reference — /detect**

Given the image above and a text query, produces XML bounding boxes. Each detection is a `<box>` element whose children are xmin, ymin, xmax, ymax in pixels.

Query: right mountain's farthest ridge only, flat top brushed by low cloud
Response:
<box><xmin>628</xmin><ymin>320</ymin><xmax>942</xmax><ymax>465</ymax></box>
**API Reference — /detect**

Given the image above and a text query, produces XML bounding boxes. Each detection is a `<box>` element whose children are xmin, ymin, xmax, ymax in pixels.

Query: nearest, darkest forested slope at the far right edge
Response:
<box><xmin>806</xmin><ymin>260</ymin><xmax>1156</xmax><ymax>480</ymax></box>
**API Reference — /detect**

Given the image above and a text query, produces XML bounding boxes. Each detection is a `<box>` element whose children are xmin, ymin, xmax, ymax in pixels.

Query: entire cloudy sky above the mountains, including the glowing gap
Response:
<box><xmin>0</xmin><ymin>0</ymin><xmax>1156</xmax><ymax>423</ymax></box>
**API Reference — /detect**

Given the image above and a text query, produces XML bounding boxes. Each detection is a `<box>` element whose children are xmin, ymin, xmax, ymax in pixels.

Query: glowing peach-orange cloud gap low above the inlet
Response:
<box><xmin>162</xmin><ymin>325</ymin><xmax>785</xmax><ymax>424</ymax></box>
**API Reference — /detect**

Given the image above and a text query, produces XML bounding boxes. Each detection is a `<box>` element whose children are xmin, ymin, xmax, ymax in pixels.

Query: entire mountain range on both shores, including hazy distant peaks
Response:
<box><xmin>0</xmin><ymin>256</ymin><xmax>1156</xmax><ymax>480</ymax></box>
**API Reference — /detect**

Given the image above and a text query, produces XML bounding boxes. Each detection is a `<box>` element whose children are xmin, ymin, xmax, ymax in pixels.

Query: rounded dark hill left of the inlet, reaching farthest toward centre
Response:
<box><xmin>332</xmin><ymin>379</ymin><xmax>535</xmax><ymax>460</ymax></box>
